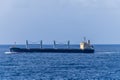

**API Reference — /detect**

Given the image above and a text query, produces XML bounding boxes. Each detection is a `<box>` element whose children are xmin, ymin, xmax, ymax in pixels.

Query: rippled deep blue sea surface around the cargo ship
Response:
<box><xmin>0</xmin><ymin>45</ymin><xmax>120</xmax><ymax>80</ymax></box>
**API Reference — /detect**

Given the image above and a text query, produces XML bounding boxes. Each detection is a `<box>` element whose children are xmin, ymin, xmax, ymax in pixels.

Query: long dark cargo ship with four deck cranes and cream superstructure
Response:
<box><xmin>10</xmin><ymin>40</ymin><xmax>95</xmax><ymax>53</ymax></box>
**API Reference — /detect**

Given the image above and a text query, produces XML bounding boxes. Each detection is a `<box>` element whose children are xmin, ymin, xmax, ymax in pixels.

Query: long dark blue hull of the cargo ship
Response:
<box><xmin>10</xmin><ymin>48</ymin><xmax>94</xmax><ymax>53</ymax></box>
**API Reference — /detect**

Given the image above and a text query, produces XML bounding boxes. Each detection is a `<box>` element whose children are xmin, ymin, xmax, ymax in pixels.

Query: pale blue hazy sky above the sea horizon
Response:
<box><xmin>0</xmin><ymin>0</ymin><xmax>120</xmax><ymax>44</ymax></box>
